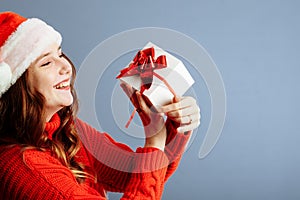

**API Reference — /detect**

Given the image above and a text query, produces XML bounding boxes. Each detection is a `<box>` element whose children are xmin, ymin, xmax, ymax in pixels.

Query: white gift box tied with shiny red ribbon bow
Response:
<box><xmin>117</xmin><ymin>42</ymin><xmax>194</xmax><ymax>107</ymax></box>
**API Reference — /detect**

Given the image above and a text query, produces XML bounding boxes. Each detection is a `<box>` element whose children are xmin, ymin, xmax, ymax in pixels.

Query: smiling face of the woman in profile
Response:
<box><xmin>28</xmin><ymin>44</ymin><xmax>73</xmax><ymax>120</ymax></box>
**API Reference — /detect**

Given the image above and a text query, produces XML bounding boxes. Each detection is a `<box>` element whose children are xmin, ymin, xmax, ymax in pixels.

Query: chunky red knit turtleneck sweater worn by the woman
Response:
<box><xmin>0</xmin><ymin>115</ymin><xmax>189</xmax><ymax>200</ymax></box>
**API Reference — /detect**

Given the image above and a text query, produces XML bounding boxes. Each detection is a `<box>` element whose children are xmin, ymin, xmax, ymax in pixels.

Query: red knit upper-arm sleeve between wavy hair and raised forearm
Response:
<box><xmin>76</xmin><ymin>119</ymin><xmax>134</xmax><ymax>192</ymax></box>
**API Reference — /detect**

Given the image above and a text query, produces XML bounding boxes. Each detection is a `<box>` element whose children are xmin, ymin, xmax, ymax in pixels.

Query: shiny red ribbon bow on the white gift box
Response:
<box><xmin>117</xmin><ymin>47</ymin><xmax>167</xmax><ymax>93</ymax></box>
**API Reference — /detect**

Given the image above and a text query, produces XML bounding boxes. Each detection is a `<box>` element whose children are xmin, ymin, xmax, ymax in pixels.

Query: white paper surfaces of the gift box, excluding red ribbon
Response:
<box><xmin>120</xmin><ymin>42</ymin><xmax>194</xmax><ymax>107</ymax></box>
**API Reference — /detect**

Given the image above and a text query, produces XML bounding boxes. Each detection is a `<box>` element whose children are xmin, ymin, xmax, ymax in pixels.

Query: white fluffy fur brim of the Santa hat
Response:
<box><xmin>0</xmin><ymin>18</ymin><xmax>62</xmax><ymax>97</ymax></box>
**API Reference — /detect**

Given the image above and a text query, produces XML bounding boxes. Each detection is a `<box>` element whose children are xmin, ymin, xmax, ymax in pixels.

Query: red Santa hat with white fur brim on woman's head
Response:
<box><xmin>0</xmin><ymin>12</ymin><xmax>62</xmax><ymax>97</ymax></box>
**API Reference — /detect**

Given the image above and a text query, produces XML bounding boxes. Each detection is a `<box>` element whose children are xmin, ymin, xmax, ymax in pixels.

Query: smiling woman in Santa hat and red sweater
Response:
<box><xmin>0</xmin><ymin>12</ymin><xmax>200</xmax><ymax>199</ymax></box>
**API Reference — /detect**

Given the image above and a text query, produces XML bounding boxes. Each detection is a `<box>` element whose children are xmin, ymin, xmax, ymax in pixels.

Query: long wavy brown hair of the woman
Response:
<box><xmin>0</xmin><ymin>55</ymin><xmax>90</xmax><ymax>182</ymax></box>
